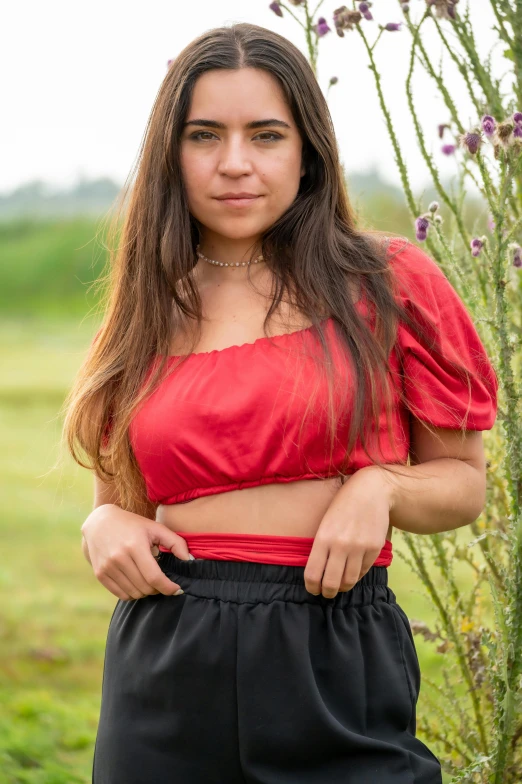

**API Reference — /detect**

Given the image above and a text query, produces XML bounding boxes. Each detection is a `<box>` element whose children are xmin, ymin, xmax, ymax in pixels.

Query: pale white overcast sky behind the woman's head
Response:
<box><xmin>0</xmin><ymin>0</ymin><xmax>502</xmax><ymax>193</ymax></box>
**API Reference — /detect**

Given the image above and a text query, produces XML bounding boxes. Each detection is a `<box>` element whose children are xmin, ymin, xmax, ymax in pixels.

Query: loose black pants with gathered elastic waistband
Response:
<box><xmin>93</xmin><ymin>553</ymin><xmax>442</xmax><ymax>784</ymax></box>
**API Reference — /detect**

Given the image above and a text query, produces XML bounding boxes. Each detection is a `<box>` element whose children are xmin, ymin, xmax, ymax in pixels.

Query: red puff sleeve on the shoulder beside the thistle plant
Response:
<box><xmin>391</xmin><ymin>243</ymin><xmax>498</xmax><ymax>430</ymax></box>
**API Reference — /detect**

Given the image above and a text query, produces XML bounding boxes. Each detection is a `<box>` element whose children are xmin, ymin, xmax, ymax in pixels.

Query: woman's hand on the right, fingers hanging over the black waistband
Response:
<box><xmin>304</xmin><ymin>466</ymin><xmax>393</xmax><ymax>599</ymax></box>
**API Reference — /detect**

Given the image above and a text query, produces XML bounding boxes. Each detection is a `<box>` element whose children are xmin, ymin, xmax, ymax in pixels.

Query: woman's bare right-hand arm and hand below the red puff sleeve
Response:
<box><xmin>304</xmin><ymin>423</ymin><xmax>486</xmax><ymax>599</ymax></box>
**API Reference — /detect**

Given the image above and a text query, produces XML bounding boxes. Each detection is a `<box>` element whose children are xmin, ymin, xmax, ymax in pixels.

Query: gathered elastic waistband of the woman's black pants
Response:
<box><xmin>157</xmin><ymin>551</ymin><xmax>397</xmax><ymax>609</ymax></box>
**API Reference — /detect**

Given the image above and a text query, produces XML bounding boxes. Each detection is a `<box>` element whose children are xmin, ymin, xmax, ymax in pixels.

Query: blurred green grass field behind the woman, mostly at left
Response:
<box><xmin>0</xmin><ymin>219</ymin><xmax>492</xmax><ymax>784</ymax></box>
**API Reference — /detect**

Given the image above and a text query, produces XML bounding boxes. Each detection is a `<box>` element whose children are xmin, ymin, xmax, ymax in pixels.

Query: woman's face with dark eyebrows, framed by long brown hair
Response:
<box><xmin>181</xmin><ymin>68</ymin><xmax>305</xmax><ymax>251</ymax></box>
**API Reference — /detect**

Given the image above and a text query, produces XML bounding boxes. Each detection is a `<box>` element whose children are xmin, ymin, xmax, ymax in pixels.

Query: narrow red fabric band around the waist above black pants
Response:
<box><xmin>159</xmin><ymin>531</ymin><xmax>393</xmax><ymax>566</ymax></box>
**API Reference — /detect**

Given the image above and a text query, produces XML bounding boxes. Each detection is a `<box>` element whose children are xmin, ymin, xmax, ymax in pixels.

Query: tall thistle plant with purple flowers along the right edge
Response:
<box><xmin>269</xmin><ymin>0</ymin><xmax>522</xmax><ymax>784</ymax></box>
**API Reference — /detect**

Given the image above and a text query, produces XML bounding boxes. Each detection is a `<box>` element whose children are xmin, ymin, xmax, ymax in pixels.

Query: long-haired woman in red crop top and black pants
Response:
<box><xmin>65</xmin><ymin>19</ymin><xmax>497</xmax><ymax>784</ymax></box>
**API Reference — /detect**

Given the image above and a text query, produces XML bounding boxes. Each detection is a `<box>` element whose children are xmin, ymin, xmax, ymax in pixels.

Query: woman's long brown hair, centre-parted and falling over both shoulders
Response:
<box><xmin>63</xmin><ymin>23</ymin><xmax>476</xmax><ymax>519</ymax></box>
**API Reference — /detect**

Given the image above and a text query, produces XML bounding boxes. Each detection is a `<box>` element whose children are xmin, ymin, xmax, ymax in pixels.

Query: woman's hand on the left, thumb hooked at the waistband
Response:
<box><xmin>81</xmin><ymin>504</ymin><xmax>190</xmax><ymax>601</ymax></box>
